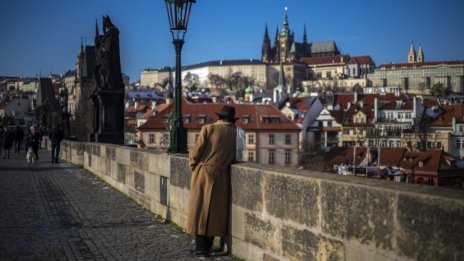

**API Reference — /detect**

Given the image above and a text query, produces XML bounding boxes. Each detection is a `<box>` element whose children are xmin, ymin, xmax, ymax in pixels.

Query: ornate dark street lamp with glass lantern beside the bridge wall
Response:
<box><xmin>165</xmin><ymin>0</ymin><xmax>195</xmax><ymax>153</ymax></box>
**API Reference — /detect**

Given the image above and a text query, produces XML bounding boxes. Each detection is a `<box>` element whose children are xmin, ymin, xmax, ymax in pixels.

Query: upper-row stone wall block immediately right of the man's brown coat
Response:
<box><xmin>231</xmin><ymin>166</ymin><xmax>263</xmax><ymax>212</ymax></box>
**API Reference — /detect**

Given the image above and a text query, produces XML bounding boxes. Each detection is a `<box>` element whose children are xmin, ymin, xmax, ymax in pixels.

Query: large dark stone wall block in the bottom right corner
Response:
<box><xmin>397</xmin><ymin>194</ymin><xmax>464</xmax><ymax>260</ymax></box>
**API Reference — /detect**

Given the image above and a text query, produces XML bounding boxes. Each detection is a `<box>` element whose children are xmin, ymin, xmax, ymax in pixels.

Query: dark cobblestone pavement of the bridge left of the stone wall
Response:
<box><xmin>0</xmin><ymin>150</ymin><xmax>233</xmax><ymax>260</ymax></box>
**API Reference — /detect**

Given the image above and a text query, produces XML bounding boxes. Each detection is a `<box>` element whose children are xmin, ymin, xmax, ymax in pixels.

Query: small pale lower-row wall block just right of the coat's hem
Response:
<box><xmin>245</xmin><ymin>213</ymin><xmax>282</xmax><ymax>253</ymax></box>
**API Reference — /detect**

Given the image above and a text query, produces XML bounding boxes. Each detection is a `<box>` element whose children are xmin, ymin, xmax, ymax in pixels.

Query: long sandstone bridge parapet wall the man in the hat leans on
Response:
<box><xmin>56</xmin><ymin>141</ymin><xmax>464</xmax><ymax>260</ymax></box>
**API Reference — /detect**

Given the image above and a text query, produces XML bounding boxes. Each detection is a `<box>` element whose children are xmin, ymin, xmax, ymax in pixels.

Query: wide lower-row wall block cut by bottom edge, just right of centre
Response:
<box><xmin>282</xmin><ymin>223</ymin><xmax>345</xmax><ymax>261</ymax></box>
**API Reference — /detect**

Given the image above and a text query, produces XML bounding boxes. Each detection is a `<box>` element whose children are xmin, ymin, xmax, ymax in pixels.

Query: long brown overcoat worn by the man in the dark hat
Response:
<box><xmin>186</xmin><ymin>120</ymin><xmax>236</xmax><ymax>236</ymax></box>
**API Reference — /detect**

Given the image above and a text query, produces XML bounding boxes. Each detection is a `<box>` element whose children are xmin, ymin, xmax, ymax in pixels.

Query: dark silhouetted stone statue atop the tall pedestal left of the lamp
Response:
<box><xmin>95</xmin><ymin>15</ymin><xmax>124</xmax><ymax>90</ymax></box>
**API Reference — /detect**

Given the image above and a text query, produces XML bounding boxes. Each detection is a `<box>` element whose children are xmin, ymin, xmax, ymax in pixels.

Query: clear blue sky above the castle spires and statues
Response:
<box><xmin>0</xmin><ymin>0</ymin><xmax>464</xmax><ymax>82</ymax></box>
